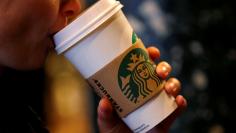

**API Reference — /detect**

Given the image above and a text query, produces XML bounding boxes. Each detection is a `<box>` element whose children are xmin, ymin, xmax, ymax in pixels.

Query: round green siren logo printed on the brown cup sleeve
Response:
<box><xmin>118</xmin><ymin>48</ymin><xmax>161</xmax><ymax>103</ymax></box>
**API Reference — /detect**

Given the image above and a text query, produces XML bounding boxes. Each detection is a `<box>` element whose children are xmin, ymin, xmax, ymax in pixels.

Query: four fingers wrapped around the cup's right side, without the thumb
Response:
<box><xmin>147</xmin><ymin>47</ymin><xmax>187</xmax><ymax>132</ymax></box>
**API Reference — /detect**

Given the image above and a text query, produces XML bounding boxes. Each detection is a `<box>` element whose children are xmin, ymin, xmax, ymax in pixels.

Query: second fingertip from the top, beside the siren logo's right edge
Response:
<box><xmin>156</xmin><ymin>61</ymin><xmax>172</xmax><ymax>79</ymax></box>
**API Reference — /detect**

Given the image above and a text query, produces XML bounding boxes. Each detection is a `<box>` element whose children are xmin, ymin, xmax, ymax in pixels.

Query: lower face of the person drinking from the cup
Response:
<box><xmin>0</xmin><ymin>0</ymin><xmax>80</xmax><ymax>69</ymax></box>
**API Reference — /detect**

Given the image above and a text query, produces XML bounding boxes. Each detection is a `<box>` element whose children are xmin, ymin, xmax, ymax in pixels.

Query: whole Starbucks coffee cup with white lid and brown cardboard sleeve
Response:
<box><xmin>54</xmin><ymin>0</ymin><xmax>177</xmax><ymax>133</ymax></box>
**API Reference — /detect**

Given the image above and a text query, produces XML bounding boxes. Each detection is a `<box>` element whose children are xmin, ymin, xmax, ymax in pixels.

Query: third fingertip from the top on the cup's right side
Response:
<box><xmin>164</xmin><ymin>78</ymin><xmax>181</xmax><ymax>97</ymax></box>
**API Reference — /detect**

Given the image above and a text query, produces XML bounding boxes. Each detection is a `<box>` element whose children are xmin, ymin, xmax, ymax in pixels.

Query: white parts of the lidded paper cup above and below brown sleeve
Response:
<box><xmin>54</xmin><ymin>0</ymin><xmax>177</xmax><ymax>133</ymax></box>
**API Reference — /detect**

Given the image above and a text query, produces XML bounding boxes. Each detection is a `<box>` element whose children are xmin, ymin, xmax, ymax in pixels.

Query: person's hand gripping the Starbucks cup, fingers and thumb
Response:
<box><xmin>97</xmin><ymin>47</ymin><xmax>187</xmax><ymax>133</ymax></box>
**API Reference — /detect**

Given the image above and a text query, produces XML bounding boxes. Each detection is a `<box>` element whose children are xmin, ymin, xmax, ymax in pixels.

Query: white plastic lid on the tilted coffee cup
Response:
<box><xmin>54</xmin><ymin>0</ymin><xmax>123</xmax><ymax>54</ymax></box>
